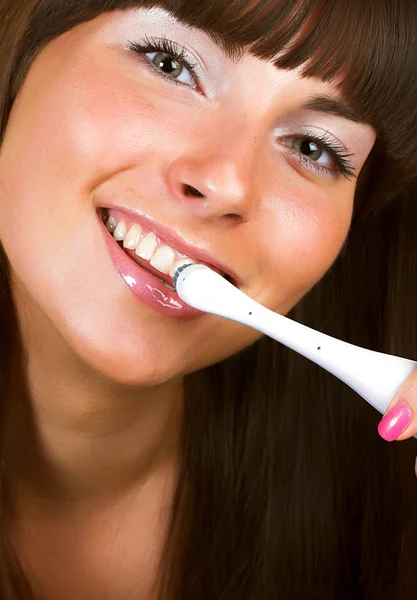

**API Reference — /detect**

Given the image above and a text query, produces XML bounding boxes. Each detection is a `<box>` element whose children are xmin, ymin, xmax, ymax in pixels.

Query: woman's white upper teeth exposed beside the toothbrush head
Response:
<box><xmin>106</xmin><ymin>216</ymin><xmax>194</xmax><ymax>277</ymax></box>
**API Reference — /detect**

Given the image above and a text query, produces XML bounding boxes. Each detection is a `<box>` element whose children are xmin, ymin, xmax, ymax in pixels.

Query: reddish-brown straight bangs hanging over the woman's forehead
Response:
<box><xmin>148</xmin><ymin>0</ymin><xmax>417</xmax><ymax>144</ymax></box>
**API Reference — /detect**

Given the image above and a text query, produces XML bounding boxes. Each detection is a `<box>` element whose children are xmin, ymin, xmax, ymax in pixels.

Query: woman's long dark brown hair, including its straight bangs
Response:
<box><xmin>0</xmin><ymin>0</ymin><xmax>417</xmax><ymax>600</ymax></box>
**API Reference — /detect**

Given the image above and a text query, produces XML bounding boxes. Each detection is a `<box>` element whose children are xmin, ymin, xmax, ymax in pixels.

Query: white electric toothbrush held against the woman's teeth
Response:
<box><xmin>174</xmin><ymin>264</ymin><xmax>417</xmax><ymax>413</ymax></box>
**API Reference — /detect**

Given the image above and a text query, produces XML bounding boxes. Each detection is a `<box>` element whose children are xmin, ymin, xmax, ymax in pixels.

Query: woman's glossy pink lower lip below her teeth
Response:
<box><xmin>100</xmin><ymin>220</ymin><xmax>203</xmax><ymax>319</ymax></box>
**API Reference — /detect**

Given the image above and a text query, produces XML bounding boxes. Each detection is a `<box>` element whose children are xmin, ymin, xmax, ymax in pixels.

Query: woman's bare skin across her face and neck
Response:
<box><xmin>0</xmin><ymin>5</ymin><xmax>375</xmax><ymax>598</ymax></box>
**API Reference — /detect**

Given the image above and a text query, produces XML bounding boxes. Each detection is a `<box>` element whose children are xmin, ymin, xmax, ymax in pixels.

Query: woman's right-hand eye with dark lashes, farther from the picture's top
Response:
<box><xmin>281</xmin><ymin>133</ymin><xmax>356</xmax><ymax>179</ymax></box>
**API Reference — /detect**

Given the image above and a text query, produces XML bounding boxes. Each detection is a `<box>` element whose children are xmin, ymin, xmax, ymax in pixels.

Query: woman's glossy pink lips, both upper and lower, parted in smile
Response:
<box><xmin>98</xmin><ymin>209</ymin><xmax>237</xmax><ymax>319</ymax></box>
